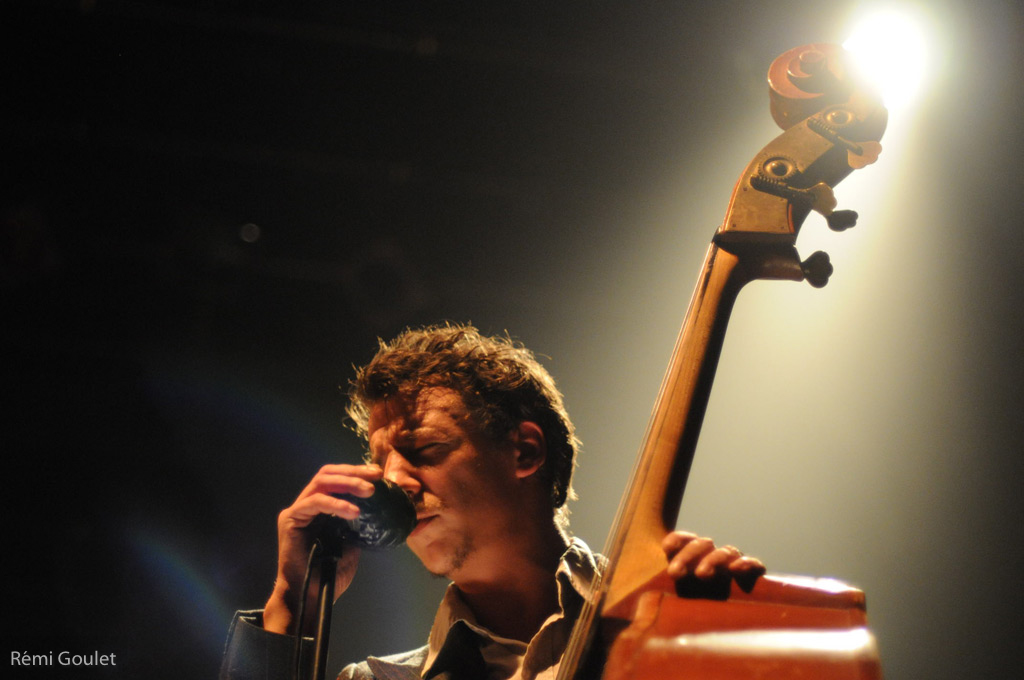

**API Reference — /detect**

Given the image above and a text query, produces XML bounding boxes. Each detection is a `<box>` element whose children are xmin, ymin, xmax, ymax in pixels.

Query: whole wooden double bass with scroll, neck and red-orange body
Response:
<box><xmin>558</xmin><ymin>44</ymin><xmax>887</xmax><ymax>680</ymax></box>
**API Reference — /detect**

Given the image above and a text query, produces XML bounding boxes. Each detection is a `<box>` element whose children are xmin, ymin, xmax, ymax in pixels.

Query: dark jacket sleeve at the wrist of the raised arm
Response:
<box><xmin>220</xmin><ymin>610</ymin><xmax>313</xmax><ymax>680</ymax></box>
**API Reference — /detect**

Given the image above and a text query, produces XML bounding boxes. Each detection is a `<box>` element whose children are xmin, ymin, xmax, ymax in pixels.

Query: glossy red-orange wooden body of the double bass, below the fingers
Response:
<box><xmin>602</xmin><ymin>576</ymin><xmax>882</xmax><ymax>680</ymax></box>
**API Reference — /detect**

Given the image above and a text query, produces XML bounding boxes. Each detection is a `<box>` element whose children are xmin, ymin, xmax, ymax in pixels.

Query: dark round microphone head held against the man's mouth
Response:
<box><xmin>311</xmin><ymin>479</ymin><xmax>416</xmax><ymax>554</ymax></box>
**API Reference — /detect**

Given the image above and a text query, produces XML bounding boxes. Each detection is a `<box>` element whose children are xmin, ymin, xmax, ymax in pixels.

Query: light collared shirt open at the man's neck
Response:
<box><xmin>423</xmin><ymin>539</ymin><xmax>604</xmax><ymax>680</ymax></box>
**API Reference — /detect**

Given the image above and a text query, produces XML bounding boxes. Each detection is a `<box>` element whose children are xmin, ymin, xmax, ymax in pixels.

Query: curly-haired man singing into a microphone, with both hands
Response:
<box><xmin>221</xmin><ymin>326</ymin><xmax>764</xmax><ymax>680</ymax></box>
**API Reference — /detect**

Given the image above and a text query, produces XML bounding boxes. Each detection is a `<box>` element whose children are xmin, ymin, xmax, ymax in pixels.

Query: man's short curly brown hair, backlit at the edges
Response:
<box><xmin>346</xmin><ymin>325</ymin><xmax>580</xmax><ymax>525</ymax></box>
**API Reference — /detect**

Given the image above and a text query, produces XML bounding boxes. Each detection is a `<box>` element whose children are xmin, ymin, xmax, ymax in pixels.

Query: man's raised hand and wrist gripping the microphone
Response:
<box><xmin>263</xmin><ymin>465</ymin><xmax>384</xmax><ymax>635</ymax></box>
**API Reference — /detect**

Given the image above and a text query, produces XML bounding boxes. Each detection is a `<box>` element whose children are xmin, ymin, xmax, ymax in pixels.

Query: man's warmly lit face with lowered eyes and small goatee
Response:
<box><xmin>368</xmin><ymin>387</ymin><xmax>519</xmax><ymax>581</ymax></box>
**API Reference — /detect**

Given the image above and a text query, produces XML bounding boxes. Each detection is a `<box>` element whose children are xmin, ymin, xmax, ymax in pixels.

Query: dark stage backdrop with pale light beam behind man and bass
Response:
<box><xmin>0</xmin><ymin>0</ymin><xmax>1024</xmax><ymax>679</ymax></box>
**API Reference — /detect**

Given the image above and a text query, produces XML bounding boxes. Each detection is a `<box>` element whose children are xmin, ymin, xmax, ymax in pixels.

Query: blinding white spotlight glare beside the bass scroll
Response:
<box><xmin>843</xmin><ymin>9</ymin><xmax>928</xmax><ymax>112</ymax></box>
